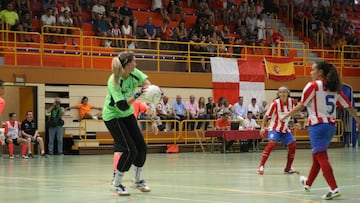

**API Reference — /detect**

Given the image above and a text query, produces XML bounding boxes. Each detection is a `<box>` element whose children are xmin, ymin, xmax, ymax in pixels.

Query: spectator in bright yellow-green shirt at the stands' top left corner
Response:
<box><xmin>0</xmin><ymin>3</ymin><xmax>25</xmax><ymax>42</ymax></box>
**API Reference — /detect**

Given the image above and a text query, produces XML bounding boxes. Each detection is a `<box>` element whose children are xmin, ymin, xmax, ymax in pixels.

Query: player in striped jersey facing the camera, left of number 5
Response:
<box><xmin>257</xmin><ymin>86</ymin><xmax>299</xmax><ymax>175</ymax></box>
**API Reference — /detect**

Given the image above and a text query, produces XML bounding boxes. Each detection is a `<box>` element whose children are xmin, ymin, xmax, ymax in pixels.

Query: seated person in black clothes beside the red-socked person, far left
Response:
<box><xmin>21</xmin><ymin>111</ymin><xmax>47</xmax><ymax>158</ymax></box>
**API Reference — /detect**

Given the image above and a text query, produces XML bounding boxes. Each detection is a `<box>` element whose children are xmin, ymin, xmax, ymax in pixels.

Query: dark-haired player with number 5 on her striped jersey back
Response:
<box><xmin>280</xmin><ymin>61</ymin><xmax>360</xmax><ymax>200</ymax></box>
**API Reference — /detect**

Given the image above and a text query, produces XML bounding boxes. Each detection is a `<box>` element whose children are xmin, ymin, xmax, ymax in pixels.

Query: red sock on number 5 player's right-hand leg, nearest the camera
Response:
<box><xmin>317</xmin><ymin>151</ymin><xmax>337</xmax><ymax>190</ymax></box>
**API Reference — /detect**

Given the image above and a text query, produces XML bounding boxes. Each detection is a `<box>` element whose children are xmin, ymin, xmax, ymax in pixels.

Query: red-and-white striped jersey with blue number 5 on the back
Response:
<box><xmin>300</xmin><ymin>80</ymin><xmax>351</xmax><ymax>125</ymax></box>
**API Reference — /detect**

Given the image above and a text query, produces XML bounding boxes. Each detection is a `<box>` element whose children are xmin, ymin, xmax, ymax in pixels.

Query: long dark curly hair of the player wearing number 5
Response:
<box><xmin>316</xmin><ymin>61</ymin><xmax>341</xmax><ymax>92</ymax></box>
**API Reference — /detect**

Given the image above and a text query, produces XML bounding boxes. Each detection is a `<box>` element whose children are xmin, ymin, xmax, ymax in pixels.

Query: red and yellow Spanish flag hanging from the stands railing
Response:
<box><xmin>264</xmin><ymin>57</ymin><xmax>296</xmax><ymax>81</ymax></box>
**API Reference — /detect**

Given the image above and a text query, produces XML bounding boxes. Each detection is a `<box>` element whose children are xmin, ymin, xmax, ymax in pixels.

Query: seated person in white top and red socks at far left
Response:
<box><xmin>4</xmin><ymin>113</ymin><xmax>29</xmax><ymax>159</ymax></box>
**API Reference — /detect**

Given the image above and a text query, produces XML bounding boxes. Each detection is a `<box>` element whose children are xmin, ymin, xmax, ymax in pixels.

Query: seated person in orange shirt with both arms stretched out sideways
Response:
<box><xmin>65</xmin><ymin>96</ymin><xmax>102</xmax><ymax>120</ymax></box>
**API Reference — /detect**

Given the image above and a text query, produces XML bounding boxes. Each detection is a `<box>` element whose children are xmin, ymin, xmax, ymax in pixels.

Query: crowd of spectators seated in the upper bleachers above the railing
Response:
<box><xmin>0</xmin><ymin>0</ymin><xmax>359</xmax><ymax>58</ymax></box>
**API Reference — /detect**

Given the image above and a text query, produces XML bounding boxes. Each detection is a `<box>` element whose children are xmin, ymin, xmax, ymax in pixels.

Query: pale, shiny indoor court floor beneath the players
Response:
<box><xmin>0</xmin><ymin>148</ymin><xmax>360</xmax><ymax>203</ymax></box>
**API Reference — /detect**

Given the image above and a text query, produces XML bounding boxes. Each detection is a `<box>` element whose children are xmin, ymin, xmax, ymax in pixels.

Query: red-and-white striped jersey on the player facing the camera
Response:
<box><xmin>265</xmin><ymin>97</ymin><xmax>296</xmax><ymax>133</ymax></box>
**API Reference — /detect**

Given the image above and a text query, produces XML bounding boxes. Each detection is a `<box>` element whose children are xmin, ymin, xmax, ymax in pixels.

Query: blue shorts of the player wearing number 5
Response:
<box><xmin>309</xmin><ymin>123</ymin><xmax>336</xmax><ymax>154</ymax></box>
